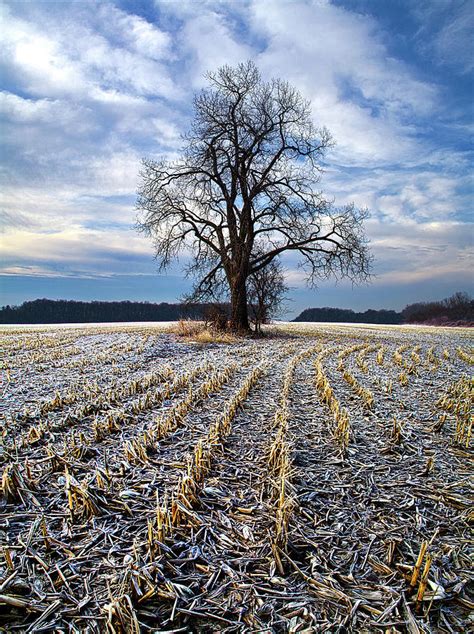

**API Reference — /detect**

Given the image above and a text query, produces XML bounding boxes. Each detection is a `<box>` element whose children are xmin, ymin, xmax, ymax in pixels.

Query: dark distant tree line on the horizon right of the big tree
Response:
<box><xmin>294</xmin><ymin>292</ymin><xmax>474</xmax><ymax>324</ymax></box>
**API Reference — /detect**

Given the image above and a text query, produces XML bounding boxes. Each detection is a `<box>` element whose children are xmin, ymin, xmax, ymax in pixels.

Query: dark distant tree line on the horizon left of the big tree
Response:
<box><xmin>0</xmin><ymin>299</ymin><xmax>224</xmax><ymax>324</ymax></box>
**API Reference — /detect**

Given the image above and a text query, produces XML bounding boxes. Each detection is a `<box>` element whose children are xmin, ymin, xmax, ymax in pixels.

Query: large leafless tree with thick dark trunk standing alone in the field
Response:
<box><xmin>137</xmin><ymin>61</ymin><xmax>371</xmax><ymax>331</ymax></box>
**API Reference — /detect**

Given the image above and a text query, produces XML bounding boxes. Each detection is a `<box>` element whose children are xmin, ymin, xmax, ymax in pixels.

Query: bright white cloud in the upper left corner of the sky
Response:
<box><xmin>2</xmin><ymin>5</ymin><xmax>178</xmax><ymax>98</ymax></box>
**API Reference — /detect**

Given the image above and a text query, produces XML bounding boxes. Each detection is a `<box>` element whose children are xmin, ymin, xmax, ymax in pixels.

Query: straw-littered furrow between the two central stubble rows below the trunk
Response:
<box><xmin>130</xmin><ymin>354</ymin><xmax>292</xmax><ymax>630</ymax></box>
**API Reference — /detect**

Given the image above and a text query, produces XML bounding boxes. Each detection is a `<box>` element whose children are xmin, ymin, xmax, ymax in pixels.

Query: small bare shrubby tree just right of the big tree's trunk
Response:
<box><xmin>247</xmin><ymin>259</ymin><xmax>288</xmax><ymax>333</ymax></box>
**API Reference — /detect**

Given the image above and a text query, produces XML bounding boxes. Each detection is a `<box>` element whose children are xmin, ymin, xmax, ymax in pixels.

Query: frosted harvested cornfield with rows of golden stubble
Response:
<box><xmin>0</xmin><ymin>324</ymin><xmax>474</xmax><ymax>634</ymax></box>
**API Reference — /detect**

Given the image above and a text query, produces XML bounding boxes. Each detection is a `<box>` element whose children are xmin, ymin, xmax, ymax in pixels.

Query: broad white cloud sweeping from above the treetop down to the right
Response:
<box><xmin>160</xmin><ymin>0</ymin><xmax>430</xmax><ymax>165</ymax></box>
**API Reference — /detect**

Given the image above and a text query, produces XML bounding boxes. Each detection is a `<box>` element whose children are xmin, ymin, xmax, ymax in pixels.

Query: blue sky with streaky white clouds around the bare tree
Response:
<box><xmin>0</xmin><ymin>0</ymin><xmax>474</xmax><ymax>317</ymax></box>
